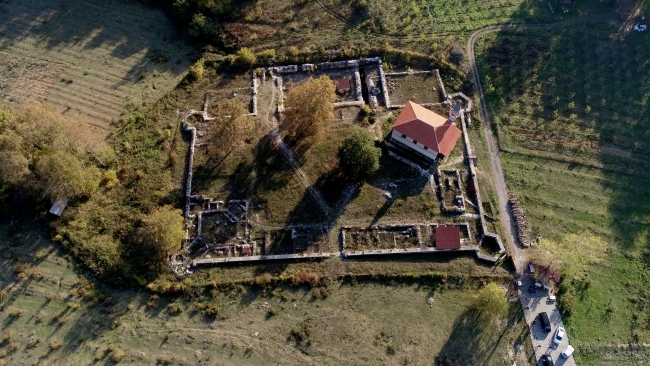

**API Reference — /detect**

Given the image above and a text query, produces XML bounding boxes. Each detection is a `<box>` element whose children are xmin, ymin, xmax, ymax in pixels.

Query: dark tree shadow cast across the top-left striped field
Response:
<box><xmin>0</xmin><ymin>0</ymin><xmax>196</xmax><ymax>96</ymax></box>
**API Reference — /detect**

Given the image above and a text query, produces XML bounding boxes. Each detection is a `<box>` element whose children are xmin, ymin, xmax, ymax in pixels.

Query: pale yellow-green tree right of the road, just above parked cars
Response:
<box><xmin>532</xmin><ymin>231</ymin><xmax>607</xmax><ymax>277</ymax></box>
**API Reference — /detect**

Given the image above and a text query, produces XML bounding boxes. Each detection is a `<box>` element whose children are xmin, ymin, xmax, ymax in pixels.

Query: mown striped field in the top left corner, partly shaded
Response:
<box><xmin>0</xmin><ymin>0</ymin><xmax>197</xmax><ymax>135</ymax></box>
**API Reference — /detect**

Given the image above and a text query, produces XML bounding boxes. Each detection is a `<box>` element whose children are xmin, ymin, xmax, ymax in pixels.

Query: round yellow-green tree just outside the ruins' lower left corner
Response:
<box><xmin>138</xmin><ymin>206</ymin><xmax>185</xmax><ymax>256</ymax></box>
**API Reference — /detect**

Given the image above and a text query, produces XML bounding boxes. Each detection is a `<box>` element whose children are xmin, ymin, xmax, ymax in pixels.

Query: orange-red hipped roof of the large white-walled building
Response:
<box><xmin>393</xmin><ymin>100</ymin><xmax>463</xmax><ymax>156</ymax></box>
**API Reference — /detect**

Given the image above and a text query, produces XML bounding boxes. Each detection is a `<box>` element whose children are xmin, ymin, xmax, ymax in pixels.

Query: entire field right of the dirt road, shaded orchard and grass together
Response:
<box><xmin>477</xmin><ymin>14</ymin><xmax>650</xmax><ymax>365</ymax></box>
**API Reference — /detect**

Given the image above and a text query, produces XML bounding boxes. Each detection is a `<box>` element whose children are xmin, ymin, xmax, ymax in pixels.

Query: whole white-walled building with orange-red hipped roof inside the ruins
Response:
<box><xmin>391</xmin><ymin>101</ymin><xmax>463</xmax><ymax>160</ymax></box>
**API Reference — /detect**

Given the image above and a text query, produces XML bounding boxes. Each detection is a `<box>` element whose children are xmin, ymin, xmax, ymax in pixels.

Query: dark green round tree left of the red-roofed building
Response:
<box><xmin>338</xmin><ymin>131</ymin><xmax>381</xmax><ymax>181</ymax></box>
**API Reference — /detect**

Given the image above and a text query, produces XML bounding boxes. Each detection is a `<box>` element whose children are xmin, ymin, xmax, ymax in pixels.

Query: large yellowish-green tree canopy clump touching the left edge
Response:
<box><xmin>0</xmin><ymin>104</ymin><xmax>109</xmax><ymax>199</ymax></box>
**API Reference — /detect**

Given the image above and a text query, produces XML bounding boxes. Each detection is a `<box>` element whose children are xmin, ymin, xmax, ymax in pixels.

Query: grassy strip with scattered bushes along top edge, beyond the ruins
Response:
<box><xmin>235</xmin><ymin>0</ymin><xmax>613</xmax><ymax>48</ymax></box>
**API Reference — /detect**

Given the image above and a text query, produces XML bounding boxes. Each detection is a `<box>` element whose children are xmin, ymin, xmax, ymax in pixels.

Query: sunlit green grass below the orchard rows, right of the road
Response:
<box><xmin>501</xmin><ymin>152</ymin><xmax>650</xmax><ymax>364</ymax></box>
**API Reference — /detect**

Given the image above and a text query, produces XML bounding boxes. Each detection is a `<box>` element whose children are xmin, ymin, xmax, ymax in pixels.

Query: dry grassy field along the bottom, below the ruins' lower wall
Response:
<box><xmin>0</xmin><ymin>222</ymin><xmax>534</xmax><ymax>365</ymax></box>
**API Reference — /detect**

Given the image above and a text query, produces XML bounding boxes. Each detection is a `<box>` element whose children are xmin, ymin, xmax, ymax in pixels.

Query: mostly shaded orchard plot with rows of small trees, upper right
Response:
<box><xmin>477</xmin><ymin>23</ymin><xmax>650</xmax><ymax>176</ymax></box>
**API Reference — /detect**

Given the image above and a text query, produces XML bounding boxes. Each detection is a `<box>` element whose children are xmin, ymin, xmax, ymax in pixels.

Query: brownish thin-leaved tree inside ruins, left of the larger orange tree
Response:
<box><xmin>210</xmin><ymin>98</ymin><xmax>255</xmax><ymax>157</ymax></box>
